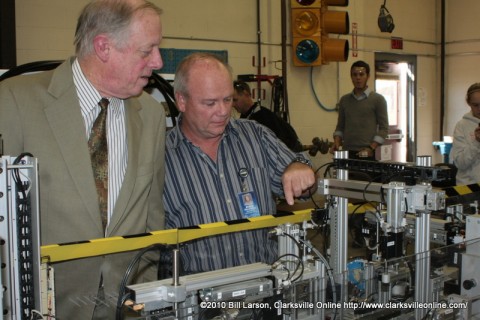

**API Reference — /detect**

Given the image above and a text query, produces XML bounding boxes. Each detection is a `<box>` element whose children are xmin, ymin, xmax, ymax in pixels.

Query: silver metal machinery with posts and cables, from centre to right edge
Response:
<box><xmin>128</xmin><ymin>153</ymin><xmax>480</xmax><ymax>320</ymax></box>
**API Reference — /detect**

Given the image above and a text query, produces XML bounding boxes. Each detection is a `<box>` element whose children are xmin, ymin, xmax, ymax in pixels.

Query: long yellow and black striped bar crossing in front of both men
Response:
<box><xmin>40</xmin><ymin>209</ymin><xmax>312</xmax><ymax>263</ymax></box>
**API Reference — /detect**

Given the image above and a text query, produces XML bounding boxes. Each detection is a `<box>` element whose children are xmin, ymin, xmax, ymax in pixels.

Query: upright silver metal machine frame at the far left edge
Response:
<box><xmin>0</xmin><ymin>155</ymin><xmax>49</xmax><ymax>320</ymax></box>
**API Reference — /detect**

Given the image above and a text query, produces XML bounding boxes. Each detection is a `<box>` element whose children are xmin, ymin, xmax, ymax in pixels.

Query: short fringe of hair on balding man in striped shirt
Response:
<box><xmin>173</xmin><ymin>52</ymin><xmax>233</xmax><ymax>97</ymax></box>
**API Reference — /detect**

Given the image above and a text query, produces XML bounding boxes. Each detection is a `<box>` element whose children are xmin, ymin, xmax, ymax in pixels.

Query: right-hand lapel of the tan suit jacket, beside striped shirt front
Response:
<box><xmin>107</xmin><ymin>99</ymin><xmax>143</xmax><ymax>235</ymax></box>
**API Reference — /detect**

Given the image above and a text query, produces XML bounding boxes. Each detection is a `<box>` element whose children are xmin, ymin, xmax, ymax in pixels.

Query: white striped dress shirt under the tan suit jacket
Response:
<box><xmin>72</xmin><ymin>59</ymin><xmax>128</xmax><ymax>230</ymax></box>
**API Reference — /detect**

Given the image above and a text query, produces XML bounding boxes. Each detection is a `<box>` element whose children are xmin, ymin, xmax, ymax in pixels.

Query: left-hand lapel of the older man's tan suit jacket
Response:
<box><xmin>45</xmin><ymin>60</ymin><xmax>103</xmax><ymax>230</ymax></box>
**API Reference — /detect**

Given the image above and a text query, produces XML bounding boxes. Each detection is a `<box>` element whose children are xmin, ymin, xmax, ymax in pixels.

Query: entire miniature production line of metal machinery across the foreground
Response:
<box><xmin>0</xmin><ymin>152</ymin><xmax>480</xmax><ymax>319</ymax></box>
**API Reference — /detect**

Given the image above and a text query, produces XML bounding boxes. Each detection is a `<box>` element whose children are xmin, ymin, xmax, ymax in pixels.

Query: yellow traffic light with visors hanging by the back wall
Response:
<box><xmin>290</xmin><ymin>0</ymin><xmax>350</xmax><ymax>67</ymax></box>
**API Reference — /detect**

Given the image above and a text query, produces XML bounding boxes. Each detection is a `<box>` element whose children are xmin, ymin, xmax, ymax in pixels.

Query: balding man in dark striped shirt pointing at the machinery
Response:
<box><xmin>164</xmin><ymin>53</ymin><xmax>316</xmax><ymax>273</ymax></box>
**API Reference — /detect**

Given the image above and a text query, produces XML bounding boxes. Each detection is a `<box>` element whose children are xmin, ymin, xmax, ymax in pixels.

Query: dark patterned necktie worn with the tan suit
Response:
<box><xmin>88</xmin><ymin>98</ymin><xmax>109</xmax><ymax>230</ymax></box>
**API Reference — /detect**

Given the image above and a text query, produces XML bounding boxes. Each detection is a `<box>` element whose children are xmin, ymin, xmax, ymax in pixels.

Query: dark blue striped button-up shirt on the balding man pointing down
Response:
<box><xmin>163</xmin><ymin>117</ymin><xmax>296</xmax><ymax>273</ymax></box>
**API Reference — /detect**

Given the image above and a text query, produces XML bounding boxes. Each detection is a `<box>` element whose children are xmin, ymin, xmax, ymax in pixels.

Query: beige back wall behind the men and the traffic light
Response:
<box><xmin>16</xmin><ymin>0</ymin><xmax>468</xmax><ymax>162</ymax></box>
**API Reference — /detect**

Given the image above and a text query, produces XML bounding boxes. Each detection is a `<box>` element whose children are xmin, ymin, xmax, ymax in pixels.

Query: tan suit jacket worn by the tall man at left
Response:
<box><xmin>0</xmin><ymin>58</ymin><xmax>165</xmax><ymax>320</ymax></box>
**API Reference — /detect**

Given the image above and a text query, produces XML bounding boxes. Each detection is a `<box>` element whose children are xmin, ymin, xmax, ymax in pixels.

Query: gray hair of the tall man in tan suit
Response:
<box><xmin>74</xmin><ymin>0</ymin><xmax>162</xmax><ymax>58</ymax></box>
